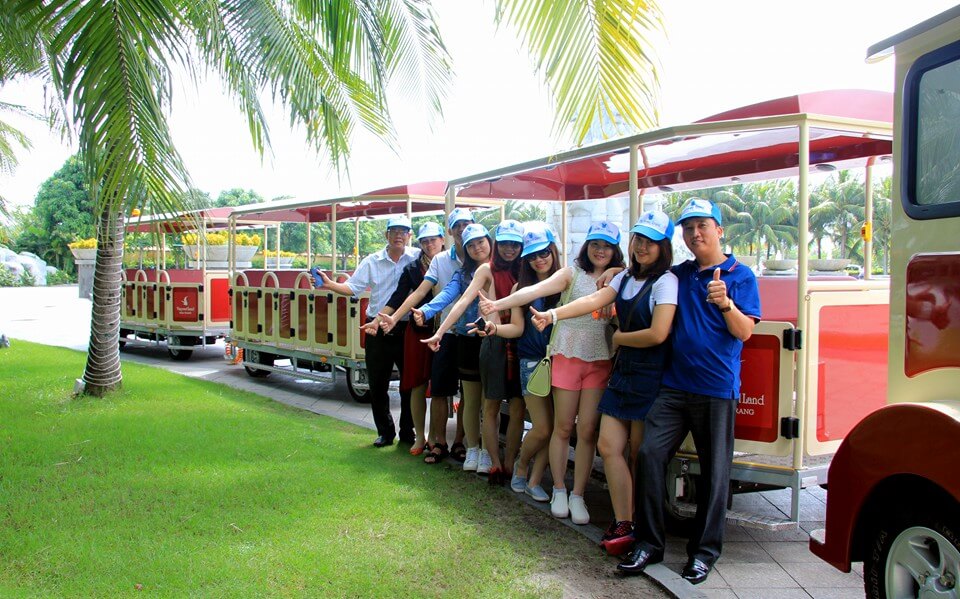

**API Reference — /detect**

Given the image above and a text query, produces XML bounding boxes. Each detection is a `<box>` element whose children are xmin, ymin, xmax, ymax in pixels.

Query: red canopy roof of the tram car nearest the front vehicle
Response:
<box><xmin>450</xmin><ymin>90</ymin><xmax>893</xmax><ymax>201</ymax></box>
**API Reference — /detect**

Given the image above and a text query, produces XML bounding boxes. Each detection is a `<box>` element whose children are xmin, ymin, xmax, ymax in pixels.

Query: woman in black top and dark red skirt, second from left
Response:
<box><xmin>363</xmin><ymin>221</ymin><xmax>447</xmax><ymax>456</ymax></box>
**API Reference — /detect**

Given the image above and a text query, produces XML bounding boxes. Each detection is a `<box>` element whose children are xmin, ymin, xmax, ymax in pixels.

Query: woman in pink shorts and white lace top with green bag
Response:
<box><xmin>481</xmin><ymin>221</ymin><xmax>623</xmax><ymax>524</ymax></box>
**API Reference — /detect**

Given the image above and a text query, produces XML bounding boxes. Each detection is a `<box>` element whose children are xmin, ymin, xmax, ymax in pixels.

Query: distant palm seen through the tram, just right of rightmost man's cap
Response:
<box><xmin>716</xmin><ymin>180</ymin><xmax>797</xmax><ymax>263</ymax></box>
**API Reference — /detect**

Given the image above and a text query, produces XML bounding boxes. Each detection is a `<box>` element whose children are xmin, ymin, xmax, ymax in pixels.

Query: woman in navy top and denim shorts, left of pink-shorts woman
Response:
<box><xmin>477</xmin><ymin>222</ymin><xmax>560</xmax><ymax>502</ymax></box>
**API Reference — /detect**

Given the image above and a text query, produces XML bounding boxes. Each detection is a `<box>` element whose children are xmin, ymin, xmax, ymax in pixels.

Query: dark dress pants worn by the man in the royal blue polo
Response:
<box><xmin>634</xmin><ymin>387</ymin><xmax>737</xmax><ymax>565</ymax></box>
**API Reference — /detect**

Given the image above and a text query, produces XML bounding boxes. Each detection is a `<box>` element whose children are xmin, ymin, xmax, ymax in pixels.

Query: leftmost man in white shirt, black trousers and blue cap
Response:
<box><xmin>319</xmin><ymin>216</ymin><xmax>419</xmax><ymax>447</ymax></box>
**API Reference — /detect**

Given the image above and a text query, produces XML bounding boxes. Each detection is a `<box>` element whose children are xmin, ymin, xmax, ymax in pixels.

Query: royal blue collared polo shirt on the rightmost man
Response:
<box><xmin>662</xmin><ymin>254</ymin><xmax>760</xmax><ymax>399</ymax></box>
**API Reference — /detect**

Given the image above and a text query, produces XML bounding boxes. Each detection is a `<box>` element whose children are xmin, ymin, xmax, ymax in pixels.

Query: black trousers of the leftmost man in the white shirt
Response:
<box><xmin>366</xmin><ymin>322</ymin><xmax>414</xmax><ymax>439</ymax></box>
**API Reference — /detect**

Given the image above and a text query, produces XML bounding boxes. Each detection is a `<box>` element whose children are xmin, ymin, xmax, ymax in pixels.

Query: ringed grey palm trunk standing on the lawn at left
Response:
<box><xmin>83</xmin><ymin>209</ymin><xmax>123</xmax><ymax>397</ymax></box>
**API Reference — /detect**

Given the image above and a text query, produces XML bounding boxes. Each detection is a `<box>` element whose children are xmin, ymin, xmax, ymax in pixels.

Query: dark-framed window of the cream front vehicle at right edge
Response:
<box><xmin>902</xmin><ymin>38</ymin><xmax>960</xmax><ymax>219</ymax></box>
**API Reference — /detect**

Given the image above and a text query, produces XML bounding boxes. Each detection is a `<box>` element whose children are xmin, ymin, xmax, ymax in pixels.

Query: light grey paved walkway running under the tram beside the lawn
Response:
<box><xmin>0</xmin><ymin>286</ymin><xmax>863</xmax><ymax>599</ymax></box>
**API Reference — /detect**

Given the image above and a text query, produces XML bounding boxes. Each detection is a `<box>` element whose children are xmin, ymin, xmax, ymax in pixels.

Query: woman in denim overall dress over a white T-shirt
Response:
<box><xmin>533</xmin><ymin>212</ymin><xmax>678</xmax><ymax>555</ymax></box>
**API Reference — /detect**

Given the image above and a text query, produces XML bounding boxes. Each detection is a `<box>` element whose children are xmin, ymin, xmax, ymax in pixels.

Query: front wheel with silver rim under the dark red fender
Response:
<box><xmin>863</xmin><ymin>504</ymin><xmax>960</xmax><ymax>599</ymax></box>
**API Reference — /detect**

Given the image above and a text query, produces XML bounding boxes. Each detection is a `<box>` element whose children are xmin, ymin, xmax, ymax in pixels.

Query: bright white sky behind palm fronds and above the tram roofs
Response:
<box><xmin>0</xmin><ymin>0</ymin><xmax>954</xmax><ymax>206</ymax></box>
